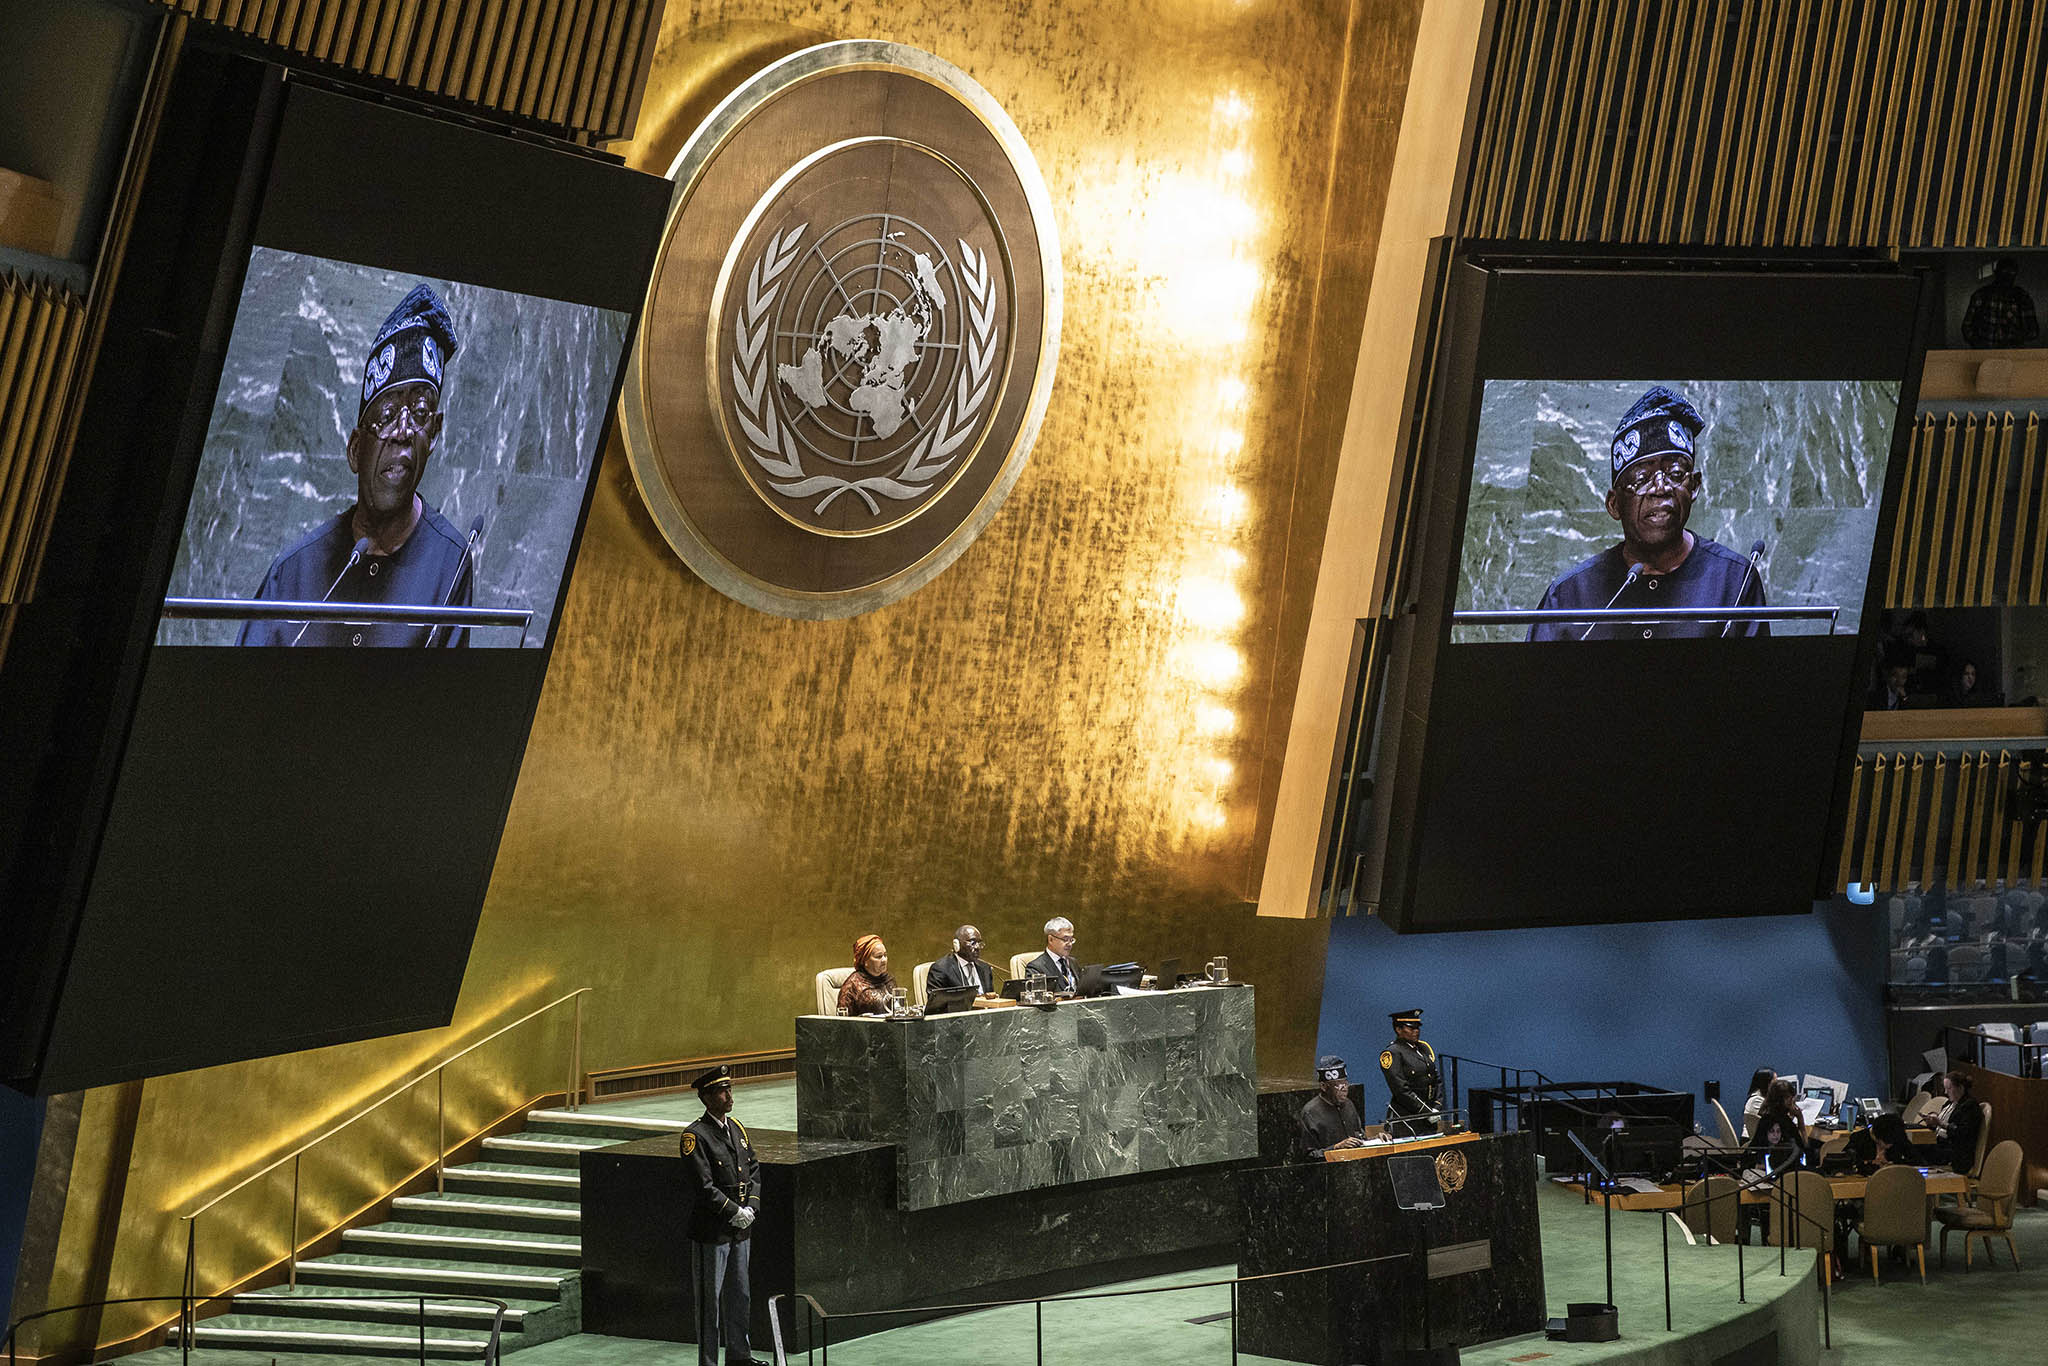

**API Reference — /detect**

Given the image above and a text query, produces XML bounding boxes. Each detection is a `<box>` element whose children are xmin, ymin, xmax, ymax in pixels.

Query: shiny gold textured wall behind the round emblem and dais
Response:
<box><xmin>51</xmin><ymin>0</ymin><xmax>1425</xmax><ymax>1339</ymax></box>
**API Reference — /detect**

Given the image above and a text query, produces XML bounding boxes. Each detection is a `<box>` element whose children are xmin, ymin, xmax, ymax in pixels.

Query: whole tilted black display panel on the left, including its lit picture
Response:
<box><xmin>0</xmin><ymin>53</ymin><xmax>670</xmax><ymax>1092</ymax></box>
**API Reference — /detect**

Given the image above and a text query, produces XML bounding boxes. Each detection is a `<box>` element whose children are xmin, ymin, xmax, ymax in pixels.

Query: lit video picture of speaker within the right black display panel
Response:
<box><xmin>1450</xmin><ymin>379</ymin><xmax>1898</xmax><ymax>643</ymax></box>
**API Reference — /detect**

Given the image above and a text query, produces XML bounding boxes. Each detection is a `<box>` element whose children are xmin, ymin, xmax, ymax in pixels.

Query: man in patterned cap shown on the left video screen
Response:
<box><xmin>236</xmin><ymin>285</ymin><xmax>475</xmax><ymax>647</ymax></box>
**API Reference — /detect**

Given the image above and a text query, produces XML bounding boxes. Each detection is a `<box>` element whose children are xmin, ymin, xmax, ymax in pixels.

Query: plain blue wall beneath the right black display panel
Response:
<box><xmin>1319</xmin><ymin>903</ymin><xmax>1886</xmax><ymax>1122</ymax></box>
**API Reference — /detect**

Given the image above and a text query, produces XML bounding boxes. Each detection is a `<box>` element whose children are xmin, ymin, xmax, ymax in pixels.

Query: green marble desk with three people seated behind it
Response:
<box><xmin>797</xmin><ymin>987</ymin><xmax>1257</xmax><ymax>1210</ymax></box>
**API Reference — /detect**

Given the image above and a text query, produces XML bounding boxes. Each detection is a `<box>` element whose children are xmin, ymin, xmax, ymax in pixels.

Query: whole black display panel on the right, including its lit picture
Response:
<box><xmin>1348</xmin><ymin>255</ymin><xmax>1927</xmax><ymax>930</ymax></box>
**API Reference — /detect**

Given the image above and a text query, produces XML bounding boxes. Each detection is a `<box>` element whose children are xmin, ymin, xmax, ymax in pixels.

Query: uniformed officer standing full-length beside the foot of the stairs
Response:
<box><xmin>682</xmin><ymin>1067</ymin><xmax>762</xmax><ymax>1366</ymax></box>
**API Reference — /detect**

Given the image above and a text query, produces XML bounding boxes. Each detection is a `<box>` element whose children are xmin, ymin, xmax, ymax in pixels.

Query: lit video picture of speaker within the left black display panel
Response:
<box><xmin>156</xmin><ymin>246</ymin><xmax>631</xmax><ymax>649</ymax></box>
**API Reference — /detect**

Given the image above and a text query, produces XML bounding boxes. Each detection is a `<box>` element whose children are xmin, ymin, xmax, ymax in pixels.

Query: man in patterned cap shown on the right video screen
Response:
<box><xmin>1530</xmin><ymin>385</ymin><xmax>1769</xmax><ymax>641</ymax></box>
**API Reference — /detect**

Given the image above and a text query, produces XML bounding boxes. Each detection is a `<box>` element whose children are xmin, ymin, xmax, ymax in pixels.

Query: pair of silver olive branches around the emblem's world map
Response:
<box><xmin>733</xmin><ymin>223</ymin><xmax>997</xmax><ymax>514</ymax></box>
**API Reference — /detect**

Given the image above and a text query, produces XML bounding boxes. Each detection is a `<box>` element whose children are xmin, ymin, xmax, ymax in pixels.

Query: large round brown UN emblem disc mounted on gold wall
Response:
<box><xmin>623</xmin><ymin>43</ymin><xmax>1061</xmax><ymax>618</ymax></box>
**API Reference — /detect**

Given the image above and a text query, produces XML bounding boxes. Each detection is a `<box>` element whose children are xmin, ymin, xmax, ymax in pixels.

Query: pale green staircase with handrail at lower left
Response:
<box><xmin>170</xmin><ymin>1110</ymin><xmax>684</xmax><ymax>1366</ymax></box>
